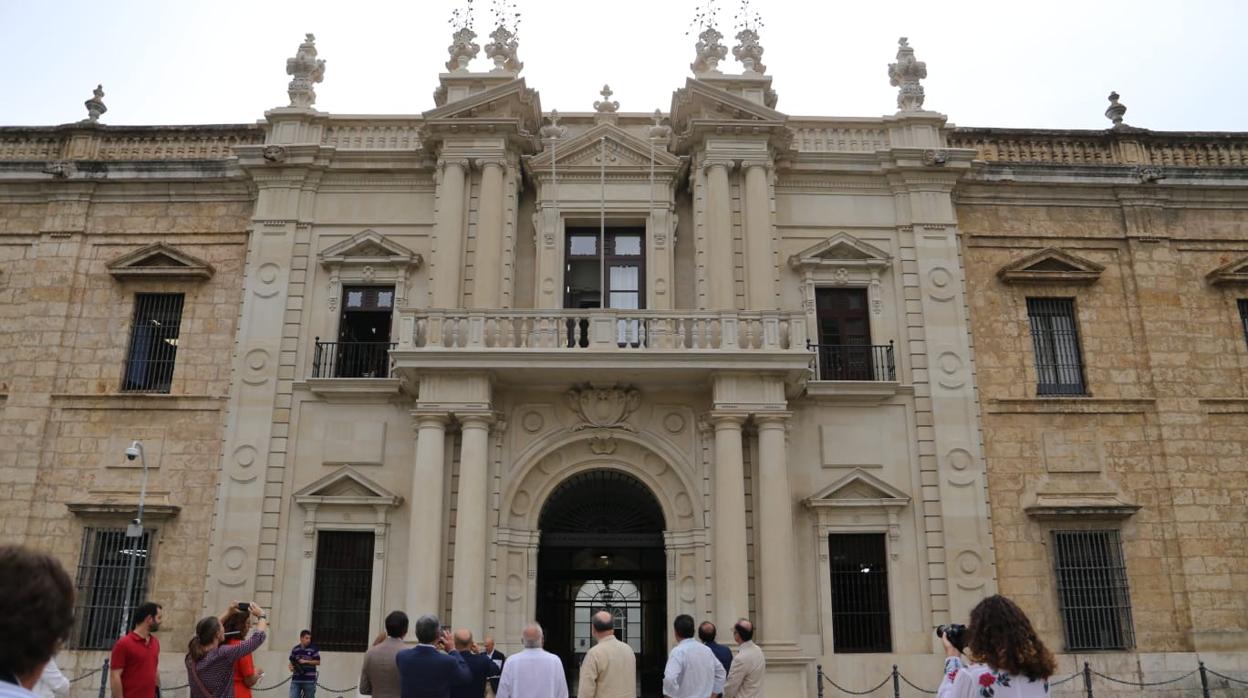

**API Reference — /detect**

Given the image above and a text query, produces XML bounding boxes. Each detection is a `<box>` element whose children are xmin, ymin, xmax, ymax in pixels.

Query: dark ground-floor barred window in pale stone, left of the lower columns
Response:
<box><xmin>312</xmin><ymin>531</ymin><xmax>373</xmax><ymax>652</ymax></box>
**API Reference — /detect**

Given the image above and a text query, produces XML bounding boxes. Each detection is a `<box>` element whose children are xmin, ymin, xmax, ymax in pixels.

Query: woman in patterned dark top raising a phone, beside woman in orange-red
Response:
<box><xmin>186</xmin><ymin>603</ymin><xmax>268</xmax><ymax>698</ymax></box>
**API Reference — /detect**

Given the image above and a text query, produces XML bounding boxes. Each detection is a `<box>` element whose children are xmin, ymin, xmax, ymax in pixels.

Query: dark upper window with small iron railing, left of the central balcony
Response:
<box><xmin>312</xmin><ymin>286</ymin><xmax>396</xmax><ymax>378</ymax></box>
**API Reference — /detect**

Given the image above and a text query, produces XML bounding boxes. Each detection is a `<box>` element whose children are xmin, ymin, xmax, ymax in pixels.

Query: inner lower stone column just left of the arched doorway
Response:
<box><xmin>451</xmin><ymin>415</ymin><xmax>493</xmax><ymax>637</ymax></box>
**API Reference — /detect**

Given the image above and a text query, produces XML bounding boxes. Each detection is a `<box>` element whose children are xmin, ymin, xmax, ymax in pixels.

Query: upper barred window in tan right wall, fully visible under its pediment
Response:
<box><xmin>1027</xmin><ymin>298</ymin><xmax>1087</xmax><ymax>395</ymax></box>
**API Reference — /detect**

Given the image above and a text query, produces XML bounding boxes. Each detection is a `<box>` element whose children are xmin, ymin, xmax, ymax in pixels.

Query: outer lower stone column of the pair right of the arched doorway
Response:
<box><xmin>748</xmin><ymin>412</ymin><xmax>797</xmax><ymax>649</ymax></box>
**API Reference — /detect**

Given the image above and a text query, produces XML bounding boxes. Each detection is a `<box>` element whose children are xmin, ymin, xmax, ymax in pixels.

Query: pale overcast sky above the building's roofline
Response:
<box><xmin>0</xmin><ymin>0</ymin><xmax>1248</xmax><ymax>130</ymax></box>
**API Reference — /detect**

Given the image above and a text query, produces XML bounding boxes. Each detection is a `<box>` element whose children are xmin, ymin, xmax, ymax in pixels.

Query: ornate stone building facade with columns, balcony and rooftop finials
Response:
<box><xmin>0</xmin><ymin>27</ymin><xmax>1248</xmax><ymax>696</ymax></box>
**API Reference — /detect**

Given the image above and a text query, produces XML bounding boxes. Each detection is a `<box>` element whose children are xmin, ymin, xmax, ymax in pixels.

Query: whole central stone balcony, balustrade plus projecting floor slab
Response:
<box><xmin>391</xmin><ymin>308</ymin><xmax>814</xmax><ymax>386</ymax></box>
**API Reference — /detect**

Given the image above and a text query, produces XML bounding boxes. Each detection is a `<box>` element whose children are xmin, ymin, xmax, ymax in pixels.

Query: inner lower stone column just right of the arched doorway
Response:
<box><xmin>710</xmin><ymin>413</ymin><xmax>748</xmax><ymax>624</ymax></box>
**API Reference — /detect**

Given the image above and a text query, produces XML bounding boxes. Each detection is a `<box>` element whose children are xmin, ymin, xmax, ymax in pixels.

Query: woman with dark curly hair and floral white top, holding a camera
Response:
<box><xmin>937</xmin><ymin>594</ymin><xmax>1057</xmax><ymax>698</ymax></box>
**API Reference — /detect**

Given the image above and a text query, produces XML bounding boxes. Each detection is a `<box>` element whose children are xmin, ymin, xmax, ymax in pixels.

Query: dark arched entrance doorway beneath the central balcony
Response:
<box><xmin>537</xmin><ymin>468</ymin><xmax>668</xmax><ymax>698</ymax></box>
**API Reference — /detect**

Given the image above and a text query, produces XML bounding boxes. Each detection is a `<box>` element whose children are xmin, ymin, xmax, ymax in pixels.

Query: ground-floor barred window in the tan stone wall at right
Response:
<box><xmin>1053</xmin><ymin>529</ymin><xmax>1136</xmax><ymax>652</ymax></box>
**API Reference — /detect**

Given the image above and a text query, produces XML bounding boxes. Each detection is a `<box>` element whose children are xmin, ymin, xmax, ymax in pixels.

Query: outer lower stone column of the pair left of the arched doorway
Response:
<box><xmin>407</xmin><ymin>411</ymin><xmax>451</xmax><ymax>616</ymax></box>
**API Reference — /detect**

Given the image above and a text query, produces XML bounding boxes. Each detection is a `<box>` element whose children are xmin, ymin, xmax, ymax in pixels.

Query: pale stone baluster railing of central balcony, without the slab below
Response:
<box><xmin>398</xmin><ymin>308</ymin><xmax>806</xmax><ymax>352</ymax></box>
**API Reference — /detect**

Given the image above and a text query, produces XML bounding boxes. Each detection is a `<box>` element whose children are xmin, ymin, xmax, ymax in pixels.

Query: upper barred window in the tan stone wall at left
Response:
<box><xmin>121</xmin><ymin>293</ymin><xmax>183</xmax><ymax>392</ymax></box>
